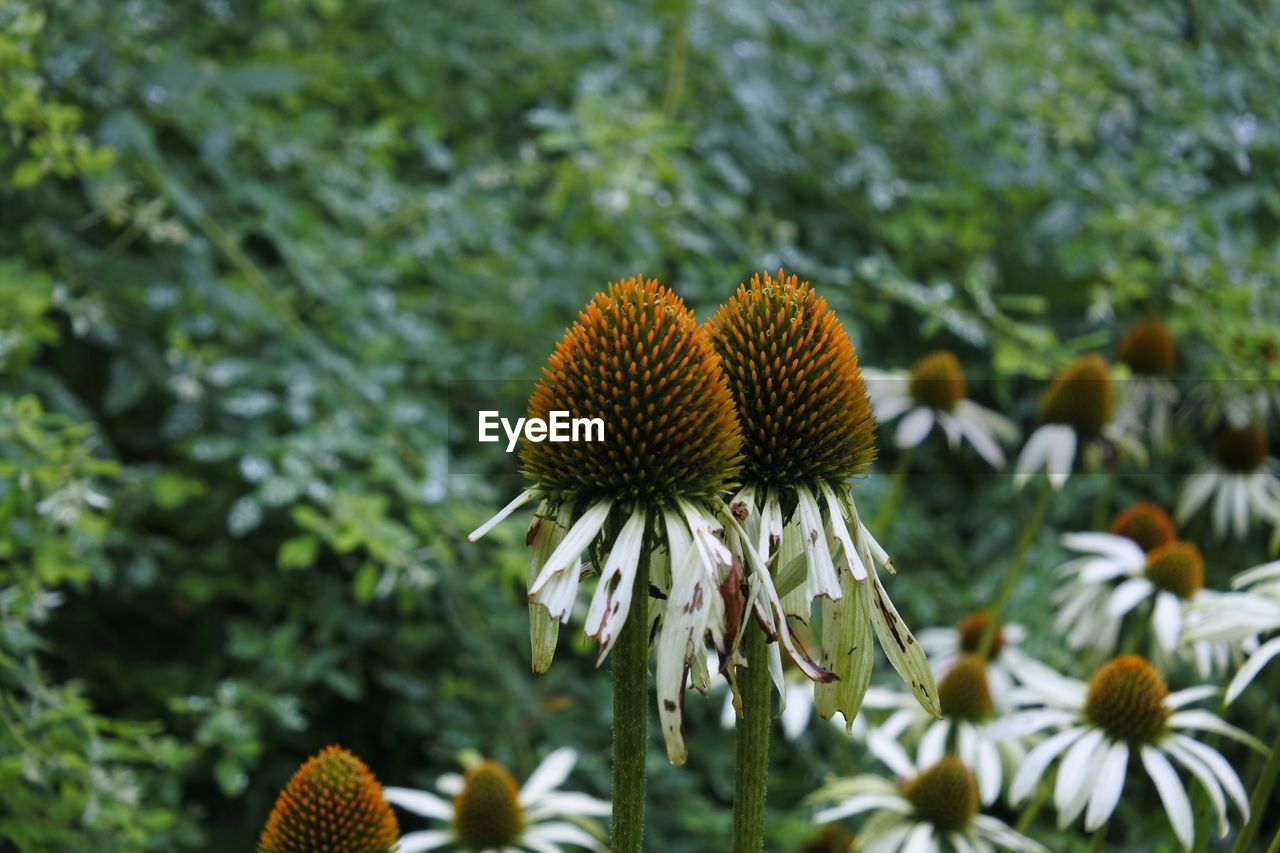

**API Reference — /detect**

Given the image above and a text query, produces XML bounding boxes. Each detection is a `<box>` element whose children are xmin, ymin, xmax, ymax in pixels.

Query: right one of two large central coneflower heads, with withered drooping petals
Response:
<box><xmin>708</xmin><ymin>270</ymin><xmax>937</xmax><ymax>726</ymax></box>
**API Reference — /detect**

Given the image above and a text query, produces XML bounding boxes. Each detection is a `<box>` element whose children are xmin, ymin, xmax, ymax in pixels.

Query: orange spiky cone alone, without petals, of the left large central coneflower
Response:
<box><xmin>520</xmin><ymin>278</ymin><xmax>742</xmax><ymax>506</ymax></box>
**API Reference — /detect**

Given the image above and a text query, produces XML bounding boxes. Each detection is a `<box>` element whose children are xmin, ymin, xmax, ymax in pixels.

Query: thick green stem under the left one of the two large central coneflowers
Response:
<box><xmin>612</xmin><ymin>553</ymin><xmax>649</xmax><ymax>853</ymax></box>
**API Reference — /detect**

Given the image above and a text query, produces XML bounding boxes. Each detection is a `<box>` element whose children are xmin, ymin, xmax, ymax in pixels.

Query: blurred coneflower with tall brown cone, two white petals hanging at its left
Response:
<box><xmin>1014</xmin><ymin>355</ymin><xmax>1147</xmax><ymax>489</ymax></box>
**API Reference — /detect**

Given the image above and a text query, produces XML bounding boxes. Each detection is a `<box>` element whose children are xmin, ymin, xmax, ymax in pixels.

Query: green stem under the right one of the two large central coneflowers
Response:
<box><xmin>730</xmin><ymin>620</ymin><xmax>773</xmax><ymax>853</ymax></box>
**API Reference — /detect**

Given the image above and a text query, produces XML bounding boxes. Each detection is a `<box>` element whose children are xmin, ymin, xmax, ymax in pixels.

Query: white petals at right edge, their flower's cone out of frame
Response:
<box><xmin>1185</xmin><ymin>561</ymin><xmax>1280</xmax><ymax>704</ymax></box>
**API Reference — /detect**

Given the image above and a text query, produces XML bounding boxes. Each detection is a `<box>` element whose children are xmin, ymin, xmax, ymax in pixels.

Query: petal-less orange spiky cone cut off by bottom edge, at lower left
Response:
<box><xmin>257</xmin><ymin>747</ymin><xmax>399</xmax><ymax>853</ymax></box>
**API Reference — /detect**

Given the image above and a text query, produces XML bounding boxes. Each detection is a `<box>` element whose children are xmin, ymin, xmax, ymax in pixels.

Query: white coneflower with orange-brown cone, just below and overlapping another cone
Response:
<box><xmin>1053</xmin><ymin>522</ymin><xmax>1231</xmax><ymax>678</ymax></box>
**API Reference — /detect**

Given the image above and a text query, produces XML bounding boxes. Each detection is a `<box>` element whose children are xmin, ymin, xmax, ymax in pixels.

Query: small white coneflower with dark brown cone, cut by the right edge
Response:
<box><xmin>1176</xmin><ymin>424</ymin><xmax>1280</xmax><ymax>539</ymax></box>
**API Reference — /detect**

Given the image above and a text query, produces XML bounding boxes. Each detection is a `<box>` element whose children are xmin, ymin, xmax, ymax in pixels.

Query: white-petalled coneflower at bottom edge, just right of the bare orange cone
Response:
<box><xmin>383</xmin><ymin>748</ymin><xmax>609</xmax><ymax>853</ymax></box>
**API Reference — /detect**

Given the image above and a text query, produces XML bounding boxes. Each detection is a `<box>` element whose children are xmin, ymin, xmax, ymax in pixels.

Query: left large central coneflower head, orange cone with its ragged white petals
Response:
<box><xmin>468</xmin><ymin>278</ymin><xmax>742</xmax><ymax>763</ymax></box>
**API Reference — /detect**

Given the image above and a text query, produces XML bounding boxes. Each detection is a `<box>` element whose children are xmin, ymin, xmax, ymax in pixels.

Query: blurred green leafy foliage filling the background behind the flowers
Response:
<box><xmin>0</xmin><ymin>0</ymin><xmax>1280</xmax><ymax>853</ymax></box>
